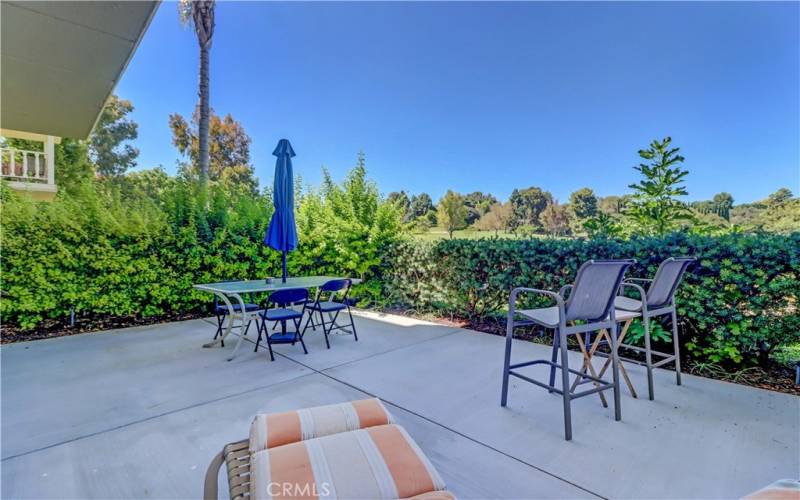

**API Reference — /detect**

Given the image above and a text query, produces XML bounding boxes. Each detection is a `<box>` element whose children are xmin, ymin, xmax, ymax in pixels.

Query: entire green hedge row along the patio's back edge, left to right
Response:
<box><xmin>0</xmin><ymin>182</ymin><xmax>800</xmax><ymax>366</ymax></box>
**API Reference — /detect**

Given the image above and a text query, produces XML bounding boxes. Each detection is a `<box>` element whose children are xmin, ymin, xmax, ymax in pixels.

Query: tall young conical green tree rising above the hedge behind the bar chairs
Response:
<box><xmin>625</xmin><ymin>137</ymin><xmax>692</xmax><ymax>235</ymax></box>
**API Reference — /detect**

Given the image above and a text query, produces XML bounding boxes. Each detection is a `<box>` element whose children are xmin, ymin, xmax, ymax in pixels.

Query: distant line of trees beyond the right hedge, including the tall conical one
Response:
<box><xmin>388</xmin><ymin>137</ymin><xmax>800</xmax><ymax>238</ymax></box>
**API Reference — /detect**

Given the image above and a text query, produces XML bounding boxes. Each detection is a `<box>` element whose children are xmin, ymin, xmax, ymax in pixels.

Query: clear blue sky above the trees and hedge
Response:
<box><xmin>117</xmin><ymin>2</ymin><xmax>800</xmax><ymax>202</ymax></box>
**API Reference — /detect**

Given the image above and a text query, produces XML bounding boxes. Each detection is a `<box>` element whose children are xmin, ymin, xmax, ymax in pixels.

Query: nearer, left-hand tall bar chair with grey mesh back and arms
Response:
<box><xmin>500</xmin><ymin>260</ymin><xmax>635</xmax><ymax>441</ymax></box>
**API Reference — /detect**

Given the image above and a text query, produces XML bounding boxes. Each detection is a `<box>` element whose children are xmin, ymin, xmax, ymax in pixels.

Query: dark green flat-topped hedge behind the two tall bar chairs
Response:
<box><xmin>383</xmin><ymin>233</ymin><xmax>800</xmax><ymax>365</ymax></box>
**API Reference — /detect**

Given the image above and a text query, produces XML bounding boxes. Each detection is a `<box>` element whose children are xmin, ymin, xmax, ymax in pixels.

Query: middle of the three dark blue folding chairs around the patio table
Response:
<box><xmin>255</xmin><ymin>288</ymin><xmax>308</xmax><ymax>361</ymax></box>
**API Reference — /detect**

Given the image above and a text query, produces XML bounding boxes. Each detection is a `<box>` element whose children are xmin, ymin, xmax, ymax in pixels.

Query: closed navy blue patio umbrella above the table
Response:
<box><xmin>264</xmin><ymin>139</ymin><xmax>297</xmax><ymax>283</ymax></box>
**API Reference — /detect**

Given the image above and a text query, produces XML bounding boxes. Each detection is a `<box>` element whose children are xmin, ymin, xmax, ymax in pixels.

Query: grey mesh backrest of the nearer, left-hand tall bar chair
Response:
<box><xmin>565</xmin><ymin>259</ymin><xmax>635</xmax><ymax>321</ymax></box>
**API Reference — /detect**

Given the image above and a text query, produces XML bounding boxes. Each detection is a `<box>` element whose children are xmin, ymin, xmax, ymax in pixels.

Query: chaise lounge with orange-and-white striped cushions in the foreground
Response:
<box><xmin>203</xmin><ymin>399</ymin><xmax>454</xmax><ymax>500</ymax></box>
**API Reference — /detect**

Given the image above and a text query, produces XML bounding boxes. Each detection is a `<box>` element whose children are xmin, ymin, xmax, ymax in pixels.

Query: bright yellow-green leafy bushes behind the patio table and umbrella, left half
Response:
<box><xmin>0</xmin><ymin>160</ymin><xmax>401</xmax><ymax>329</ymax></box>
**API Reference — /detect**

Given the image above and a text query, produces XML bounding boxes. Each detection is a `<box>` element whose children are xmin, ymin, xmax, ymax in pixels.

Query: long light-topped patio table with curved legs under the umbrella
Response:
<box><xmin>193</xmin><ymin>276</ymin><xmax>361</xmax><ymax>361</ymax></box>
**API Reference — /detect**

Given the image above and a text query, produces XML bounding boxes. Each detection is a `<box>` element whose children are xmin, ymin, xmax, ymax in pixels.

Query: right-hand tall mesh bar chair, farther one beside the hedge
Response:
<box><xmin>600</xmin><ymin>257</ymin><xmax>697</xmax><ymax>400</ymax></box>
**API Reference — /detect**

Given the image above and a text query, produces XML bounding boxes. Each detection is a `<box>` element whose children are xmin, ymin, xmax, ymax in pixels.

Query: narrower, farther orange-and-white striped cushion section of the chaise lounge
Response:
<box><xmin>250</xmin><ymin>398</ymin><xmax>394</xmax><ymax>453</ymax></box>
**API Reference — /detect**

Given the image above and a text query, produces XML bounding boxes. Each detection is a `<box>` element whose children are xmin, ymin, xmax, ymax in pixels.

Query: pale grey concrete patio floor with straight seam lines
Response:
<box><xmin>0</xmin><ymin>312</ymin><xmax>800</xmax><ymax>498</ymax></box>
